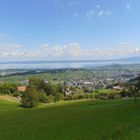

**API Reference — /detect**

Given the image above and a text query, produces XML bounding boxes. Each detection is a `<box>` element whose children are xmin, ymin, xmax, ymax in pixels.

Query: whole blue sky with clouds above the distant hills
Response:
<box><xmin>0</xmin><ymin>0</ymin><xmax>140</xmax><ymax>60</ymax></box>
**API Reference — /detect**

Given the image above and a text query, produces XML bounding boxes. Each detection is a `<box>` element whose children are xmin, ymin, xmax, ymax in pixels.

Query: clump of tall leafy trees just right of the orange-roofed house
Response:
<box><xmin>21</xmin><ymin>78</ymin><xmax>64</xmax><ymax>107</ymax></box>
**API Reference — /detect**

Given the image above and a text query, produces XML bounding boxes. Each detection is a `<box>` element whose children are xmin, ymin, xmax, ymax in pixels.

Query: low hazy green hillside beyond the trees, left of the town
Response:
<box><xmin>0</xmin><ymin>70</ymin><xmax>88</xmax><ymax>83</ymax></box>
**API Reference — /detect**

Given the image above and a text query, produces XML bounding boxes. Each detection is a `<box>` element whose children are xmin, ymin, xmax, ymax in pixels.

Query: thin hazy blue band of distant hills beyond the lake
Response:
<box><xmin>0</xmin><ymin>56</ymin><xmax>140</xmax><ymax>64</ymax></box>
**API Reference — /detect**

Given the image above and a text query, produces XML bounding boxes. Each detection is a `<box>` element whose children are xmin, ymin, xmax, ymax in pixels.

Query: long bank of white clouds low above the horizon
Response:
<box><xmin>0</xmin><ymin>42</ymin><xmax>140</xmax><ymax>60</ymax></box>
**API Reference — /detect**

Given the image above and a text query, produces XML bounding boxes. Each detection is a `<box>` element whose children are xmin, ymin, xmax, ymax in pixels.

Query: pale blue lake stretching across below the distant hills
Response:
<box><xmin>0</xmin><ymin>61</ymin><xmax>140</xmax><ymax>70</ymax></box>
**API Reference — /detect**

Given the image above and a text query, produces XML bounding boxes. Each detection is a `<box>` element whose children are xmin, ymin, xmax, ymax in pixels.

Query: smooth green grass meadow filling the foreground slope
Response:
<box><xmin>0</xmin><ymin>98</ymin><xmax>140</xmax><ymax>140</ymax></box>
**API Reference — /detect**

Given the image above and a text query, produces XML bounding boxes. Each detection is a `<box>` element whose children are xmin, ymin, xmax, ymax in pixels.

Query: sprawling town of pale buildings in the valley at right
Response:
<box><xmin>66</xmin><ymin>71</ymin><xmax>138</xmax><ymax>91</ymax></box>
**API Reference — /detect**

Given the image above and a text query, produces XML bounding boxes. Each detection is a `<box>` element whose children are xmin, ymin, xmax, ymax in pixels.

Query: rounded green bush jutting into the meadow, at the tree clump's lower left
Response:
<box><xmin>21</xmin><ymin>88</ymin><xmax>39</xmax><ymax>108</ymax></box>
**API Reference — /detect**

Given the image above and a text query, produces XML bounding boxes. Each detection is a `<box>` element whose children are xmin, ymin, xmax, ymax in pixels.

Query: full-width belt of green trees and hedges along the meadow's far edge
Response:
<box><xmin>0</xmin><ymin>77</ymin><xmax>140</xmax><ymax>108</ymax></box>
